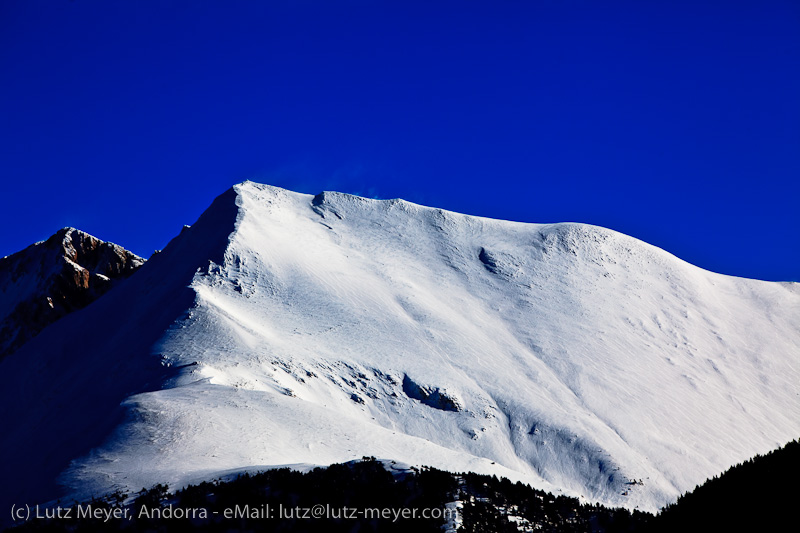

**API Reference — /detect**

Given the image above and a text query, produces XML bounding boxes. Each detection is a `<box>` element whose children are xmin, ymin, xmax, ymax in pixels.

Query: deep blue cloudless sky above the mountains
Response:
<box><xmin>0</xmin><ymin>0</ymin><xmax>800</xmax><ymax>281</ymax></box>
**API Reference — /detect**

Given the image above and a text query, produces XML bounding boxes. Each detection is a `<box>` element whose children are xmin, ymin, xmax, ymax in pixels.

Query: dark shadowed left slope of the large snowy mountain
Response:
<box><xmin>0</xmin><ymin>190</ymin><xmax>238</xmax><ymax>508</ymax></box>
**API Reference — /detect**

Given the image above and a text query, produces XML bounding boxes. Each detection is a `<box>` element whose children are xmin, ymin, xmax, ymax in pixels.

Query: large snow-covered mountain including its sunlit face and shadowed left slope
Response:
<box><xmin>0</xmin><ymin>182</ymin><xmax>800</xmax><ymax>510</ymax></box>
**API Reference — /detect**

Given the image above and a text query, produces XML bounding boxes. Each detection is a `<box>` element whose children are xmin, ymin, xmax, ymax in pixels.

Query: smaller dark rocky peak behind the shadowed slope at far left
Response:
<box><xmin>0</xmin><ymin>228</ymin><xmax>145</xmax><ymax>359</ymax></box>
